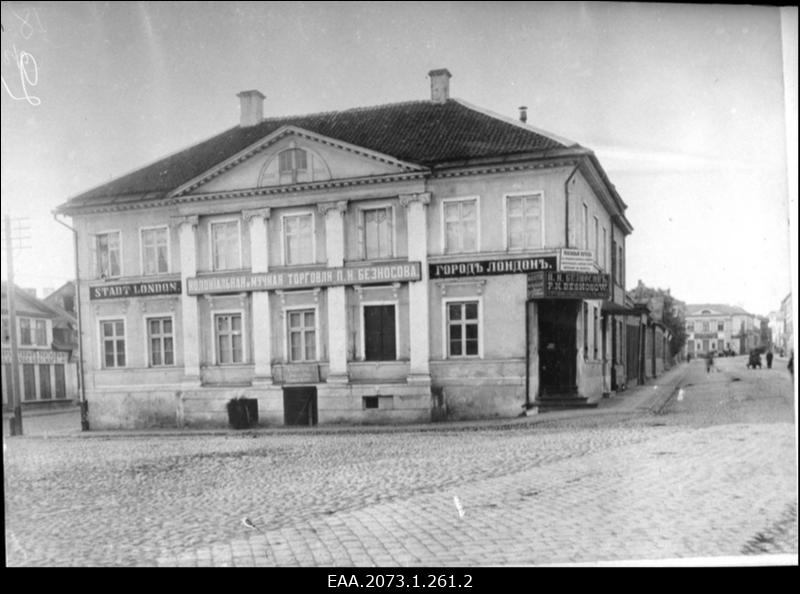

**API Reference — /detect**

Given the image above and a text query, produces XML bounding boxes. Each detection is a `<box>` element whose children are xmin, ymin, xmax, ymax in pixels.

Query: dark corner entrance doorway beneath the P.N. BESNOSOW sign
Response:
<box><xmin>537</xmin><ymin>299</ymin><xmax>581</xmax><ymax>396</ymax></box>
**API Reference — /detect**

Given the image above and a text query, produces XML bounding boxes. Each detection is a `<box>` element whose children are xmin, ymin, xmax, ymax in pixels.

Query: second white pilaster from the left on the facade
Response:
<box><xmin>242</xmin><ymin>208</ymin><xmax>272</xmax><ymax>383</ymax></box>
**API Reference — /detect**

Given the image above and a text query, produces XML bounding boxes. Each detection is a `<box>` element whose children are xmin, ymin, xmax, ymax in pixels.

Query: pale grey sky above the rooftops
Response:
<box><xmin>0</xmin><ymin>2</ymin><xmax>796</xmax><ymax>314</ymax></box>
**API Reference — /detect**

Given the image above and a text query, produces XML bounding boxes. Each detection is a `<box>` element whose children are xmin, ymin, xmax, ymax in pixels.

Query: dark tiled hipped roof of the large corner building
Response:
<box><xmin>58</xmin><ymin>99</ymin><xmax>580</xmax><ymax>210</ymax></box>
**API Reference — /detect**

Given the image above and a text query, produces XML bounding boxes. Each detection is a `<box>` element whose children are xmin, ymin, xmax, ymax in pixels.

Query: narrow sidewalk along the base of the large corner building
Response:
<box><xmin>23</xmin><ymin>363</ymin><xmax>690</xmax><ymax>438</ymax></box>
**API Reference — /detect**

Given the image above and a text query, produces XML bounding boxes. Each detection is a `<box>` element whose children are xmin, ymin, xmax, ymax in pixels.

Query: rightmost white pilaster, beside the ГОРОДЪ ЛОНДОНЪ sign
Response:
<box><xmin>400</xmin><ymin>192</ymin><xmax>431</xmax><ymax>383</ymax></box>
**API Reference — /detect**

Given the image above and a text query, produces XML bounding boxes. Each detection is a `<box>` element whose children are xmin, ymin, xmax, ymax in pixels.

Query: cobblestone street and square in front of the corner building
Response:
<box><xmin>4</xmin><ymin>360</ymin><xmax>797</xmax><ymax>567</ymax></box>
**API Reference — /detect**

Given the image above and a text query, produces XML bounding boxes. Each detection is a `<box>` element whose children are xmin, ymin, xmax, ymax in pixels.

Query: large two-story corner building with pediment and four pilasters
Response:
<box><xmin>53</xmin><ymin>69</ymin><xmax>632</xmax><ymax>428</ymax></box>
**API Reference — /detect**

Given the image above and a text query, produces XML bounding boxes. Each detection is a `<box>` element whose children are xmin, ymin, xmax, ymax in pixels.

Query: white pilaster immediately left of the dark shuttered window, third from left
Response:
<box><xmin>318</xmin><ymin>200</ymin><xmax>347</xmax><ymax>382</ymax></box>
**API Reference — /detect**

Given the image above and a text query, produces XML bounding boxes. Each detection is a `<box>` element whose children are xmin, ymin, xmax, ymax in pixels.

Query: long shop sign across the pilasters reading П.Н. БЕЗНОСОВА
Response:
<box><xmin>186</xmin><ymin>262</ymin><xmax>421</xmax><ymax>295</ymax></box>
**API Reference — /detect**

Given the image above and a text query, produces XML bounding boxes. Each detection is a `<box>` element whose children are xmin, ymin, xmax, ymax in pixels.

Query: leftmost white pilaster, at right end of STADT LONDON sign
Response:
<box><xmin>172</xmin><ymin>215</ymin><xmax>200</xmax><ymax>384</ymax></box>
